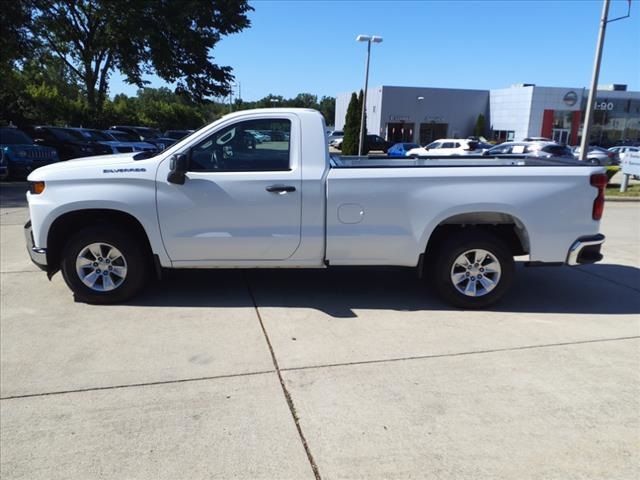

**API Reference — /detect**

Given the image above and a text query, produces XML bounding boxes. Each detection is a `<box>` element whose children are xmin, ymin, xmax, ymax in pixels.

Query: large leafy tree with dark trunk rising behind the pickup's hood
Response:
<box><xmin>25</xmin><ymin>0</ymin><xmax>253</xmax><ymax>116</ymax></box>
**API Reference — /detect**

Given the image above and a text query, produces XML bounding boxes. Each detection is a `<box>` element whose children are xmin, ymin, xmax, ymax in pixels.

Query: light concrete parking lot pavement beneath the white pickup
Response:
<box><xmin>0</xmin><ymin>183</ymin><xmax>640</xmax><ymax>480</ymax></box>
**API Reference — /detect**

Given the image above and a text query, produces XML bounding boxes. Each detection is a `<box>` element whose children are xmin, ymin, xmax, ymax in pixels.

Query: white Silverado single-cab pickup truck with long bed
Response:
<box><xmin>25</xmin><ymin>108</ymin><xmax>607</xmax><ymax>308</ymax></box>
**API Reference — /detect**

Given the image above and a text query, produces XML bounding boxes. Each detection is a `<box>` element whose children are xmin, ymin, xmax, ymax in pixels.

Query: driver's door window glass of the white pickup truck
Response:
<box><xmin>189</xmin><ymin>119</ymin><xmax>291</xmax><ymax>172</ymax></box>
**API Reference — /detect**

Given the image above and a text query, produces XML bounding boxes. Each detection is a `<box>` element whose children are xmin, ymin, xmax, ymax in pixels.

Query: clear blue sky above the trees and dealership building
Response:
<box><xmin>110</xmin><ymin>0</ymin><xmax>640</xmax><ymax>101</ymax></box>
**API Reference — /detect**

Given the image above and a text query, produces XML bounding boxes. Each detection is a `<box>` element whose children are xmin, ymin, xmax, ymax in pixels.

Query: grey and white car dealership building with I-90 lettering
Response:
<box><xmin>335</xmin><ymin>84</ymin><xmax>640</xmax><ymax>146</ymax></box>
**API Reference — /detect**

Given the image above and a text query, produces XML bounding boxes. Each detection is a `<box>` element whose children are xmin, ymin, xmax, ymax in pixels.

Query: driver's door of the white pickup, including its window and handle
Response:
<box><xmin>157</xmin><ymin>115</ymin><xmax>302</xmax><ymax>264</ymax></box>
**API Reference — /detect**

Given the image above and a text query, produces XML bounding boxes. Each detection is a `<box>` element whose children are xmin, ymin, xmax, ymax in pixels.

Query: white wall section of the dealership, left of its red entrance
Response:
<box><xmin>489</xmin><ymin>86</ymin><xmax>542</xmax><ymax>140</ymax></box>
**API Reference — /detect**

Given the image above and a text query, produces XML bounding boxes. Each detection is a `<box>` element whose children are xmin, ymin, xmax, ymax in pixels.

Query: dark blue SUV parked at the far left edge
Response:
<box><xmin>0</xmin><ymin>127</ymin><xmax>60</xmax><ymax>178</ymax></box>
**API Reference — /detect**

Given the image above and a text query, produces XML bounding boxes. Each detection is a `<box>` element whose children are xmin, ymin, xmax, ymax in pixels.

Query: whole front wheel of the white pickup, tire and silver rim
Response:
<box><xmin>61</xmin><ymin>227</ymin><xmax>148</xmax><ymax>304</ymax></box>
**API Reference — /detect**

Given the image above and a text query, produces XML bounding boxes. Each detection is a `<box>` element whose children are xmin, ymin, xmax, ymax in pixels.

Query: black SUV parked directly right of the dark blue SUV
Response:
<box><xmin>27</xmin><ymin>126</ymin><xmax>112</xmax><ymax>160</ymax></box>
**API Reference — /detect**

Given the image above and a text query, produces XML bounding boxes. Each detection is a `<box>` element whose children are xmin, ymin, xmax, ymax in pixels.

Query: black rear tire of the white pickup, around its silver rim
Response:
<box><xmin>424</xmin><ymin>228</ymin><xmax>515</xmax><ymax>309</ymax></box>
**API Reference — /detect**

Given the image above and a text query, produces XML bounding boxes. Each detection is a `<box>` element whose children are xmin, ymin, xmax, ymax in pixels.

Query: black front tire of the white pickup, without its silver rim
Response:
<box><xmin>60</xmin><ymin>225</ymin><xmax>150</xmax><ymax>304</ymax></box>
